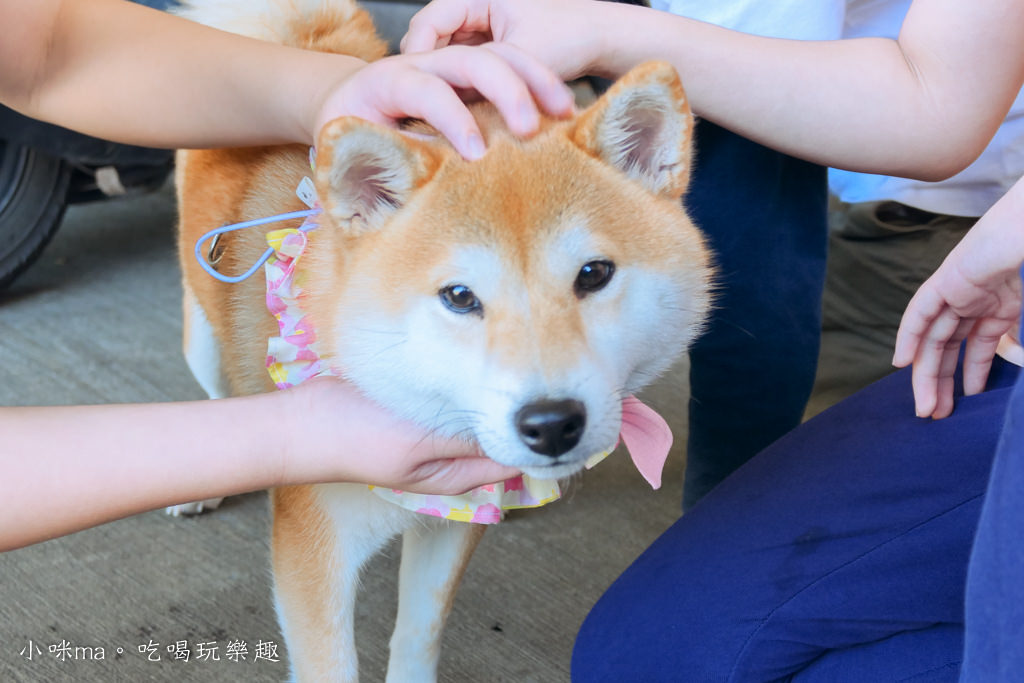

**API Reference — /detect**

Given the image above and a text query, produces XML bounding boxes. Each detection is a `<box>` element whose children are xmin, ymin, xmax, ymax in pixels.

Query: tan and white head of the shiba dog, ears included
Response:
<box><xmin>303</xmin><ymin>62</ymin><xmax>711</xmax><ymax>478</ymax></box>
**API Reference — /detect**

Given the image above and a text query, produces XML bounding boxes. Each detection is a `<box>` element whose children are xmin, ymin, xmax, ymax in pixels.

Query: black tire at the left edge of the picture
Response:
<box><xmin>0</xmin><ymin>140</ymin><xmax>71</xmax><ymax>289</ymax></box>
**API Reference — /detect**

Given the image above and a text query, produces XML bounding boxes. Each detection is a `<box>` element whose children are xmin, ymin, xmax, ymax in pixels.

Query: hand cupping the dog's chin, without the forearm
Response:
<box><xmin>270</xmin><ymin>377</ymin><xmax>519</xmax><ymax>495</ymax></box>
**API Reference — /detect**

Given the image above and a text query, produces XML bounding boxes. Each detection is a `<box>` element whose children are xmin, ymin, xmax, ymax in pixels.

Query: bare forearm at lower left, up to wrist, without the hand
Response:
<box><xmin>0</xmin><ymin>395</ymin><xmax>285</xmax><ymax>551</ymax></box>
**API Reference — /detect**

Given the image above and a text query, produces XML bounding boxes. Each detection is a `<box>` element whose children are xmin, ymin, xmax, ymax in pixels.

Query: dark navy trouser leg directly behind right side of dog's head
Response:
<box><xmin>683</xmin><ymin>121</ymin><xmax>827</xmax><ymax>509</ymax></box>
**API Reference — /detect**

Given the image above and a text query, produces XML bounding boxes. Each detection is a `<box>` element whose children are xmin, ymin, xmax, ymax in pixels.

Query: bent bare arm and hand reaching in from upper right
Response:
<box><xmin>402</xmin><ymin>0</ymin><xmax>1024</xmax><ymax>180</ymax></box>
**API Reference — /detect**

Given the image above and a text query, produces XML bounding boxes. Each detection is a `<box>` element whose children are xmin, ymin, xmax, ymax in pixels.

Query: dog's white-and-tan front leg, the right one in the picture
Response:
<box><xmin>387</xmin><ymin>519</ymin><xmax>486</xmax><ymax>683</ymax></box>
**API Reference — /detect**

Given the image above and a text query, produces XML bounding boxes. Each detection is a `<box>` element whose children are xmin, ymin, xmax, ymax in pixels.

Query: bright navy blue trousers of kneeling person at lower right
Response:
<box><xmin>572</xmin><ymin>359</ymin><xmax>1024</xmax><ymax>683</ymax></box>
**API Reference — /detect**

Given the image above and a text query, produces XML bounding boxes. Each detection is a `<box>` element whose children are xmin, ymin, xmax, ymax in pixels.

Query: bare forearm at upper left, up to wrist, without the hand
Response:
<box><xmin>0</xmin><ymin>0</ymin><xmax>364</xmax><ymax>147</ymax></box>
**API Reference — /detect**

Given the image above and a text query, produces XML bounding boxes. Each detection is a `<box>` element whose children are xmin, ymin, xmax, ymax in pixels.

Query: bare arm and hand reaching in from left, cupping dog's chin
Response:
<box><xmin>0</xmin><ymin>379</ymin><xmax>518</xmax><ymax>551</ymax></box>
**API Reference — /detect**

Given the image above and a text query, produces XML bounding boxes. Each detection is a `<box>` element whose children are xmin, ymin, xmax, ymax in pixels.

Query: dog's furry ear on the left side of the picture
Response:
<box><xmin>315</xmin><ymin>117</ymin><xmax>440</xmax><ymax>233</ymax></box>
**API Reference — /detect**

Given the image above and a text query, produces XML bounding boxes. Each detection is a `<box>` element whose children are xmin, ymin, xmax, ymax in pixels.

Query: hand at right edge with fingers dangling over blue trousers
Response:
<box><xmin>893</xmin><ymin>180</ymin><xmax>1024</xmax><ymax>419</ymax></box>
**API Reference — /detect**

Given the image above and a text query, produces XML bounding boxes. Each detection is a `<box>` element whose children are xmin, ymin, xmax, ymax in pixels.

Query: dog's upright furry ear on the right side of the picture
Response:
<box><xmin>571</xmin><ymin>61</ymin><xmax>693</xmax><ymax>199</ymax></box>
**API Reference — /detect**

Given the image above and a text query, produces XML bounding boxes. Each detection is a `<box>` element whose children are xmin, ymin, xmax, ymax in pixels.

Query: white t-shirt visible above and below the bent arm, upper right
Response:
<box><xmin>651</xmin><ymin>0</ymin><xmax>1024</xmax><ymax>216</ymax></box>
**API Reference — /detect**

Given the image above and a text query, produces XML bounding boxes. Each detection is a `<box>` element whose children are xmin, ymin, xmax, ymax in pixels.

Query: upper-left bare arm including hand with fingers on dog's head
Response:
<box><xmin>0</xmin><ymin>0</ymin><xmax>572</xmax><ymax>157</ymax></box>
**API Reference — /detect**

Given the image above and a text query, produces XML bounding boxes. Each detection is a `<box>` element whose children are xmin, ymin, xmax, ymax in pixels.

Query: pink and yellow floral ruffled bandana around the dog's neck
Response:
<box><xmin>264</xmin><ymin>222</ymin><xmax>672</xmax><ymax>524</ymax></box>
